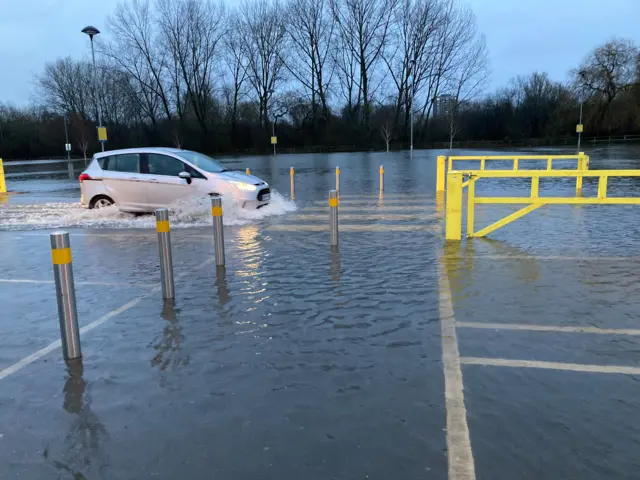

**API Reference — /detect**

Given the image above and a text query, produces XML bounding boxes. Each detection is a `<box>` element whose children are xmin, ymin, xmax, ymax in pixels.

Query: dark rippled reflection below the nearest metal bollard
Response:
<box><xmin>44</xmin><ymin>362</ymin><xmax>110</xmax><ymax>480</ymax></box>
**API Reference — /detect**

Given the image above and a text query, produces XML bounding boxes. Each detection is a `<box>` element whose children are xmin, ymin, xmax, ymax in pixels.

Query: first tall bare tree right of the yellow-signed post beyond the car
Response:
<box><xmin>285</xmin><ymin>0</ymin><xmax>334</xmax><ymax>129</ymax></box>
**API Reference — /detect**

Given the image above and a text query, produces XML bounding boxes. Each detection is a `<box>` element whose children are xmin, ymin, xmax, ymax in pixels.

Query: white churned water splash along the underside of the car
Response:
<box><xmin>0</xmin><ymin>192</ymin><xmax>296</xmax><ymax>230</ymax></box>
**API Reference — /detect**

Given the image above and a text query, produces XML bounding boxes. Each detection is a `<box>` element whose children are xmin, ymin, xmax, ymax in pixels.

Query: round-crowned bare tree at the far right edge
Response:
<box><xmin>571</xmin><ymin>39</ymin><xmax>640</xmax><ymax>130</ymax></box>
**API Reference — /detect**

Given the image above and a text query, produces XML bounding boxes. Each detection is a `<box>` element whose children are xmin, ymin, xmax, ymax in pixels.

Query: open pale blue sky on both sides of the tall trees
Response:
<box><xmin>0</xmin><ymin>0</ymin><xmax>640</xmax><ymax>105</ymax></box>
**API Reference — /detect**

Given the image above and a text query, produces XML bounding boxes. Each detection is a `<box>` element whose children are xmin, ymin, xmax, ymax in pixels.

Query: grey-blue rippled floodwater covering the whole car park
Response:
<box><xmin>0</xmin><ymin>147</ymin><xmax>640</xmax><ymax>480</ymax></box>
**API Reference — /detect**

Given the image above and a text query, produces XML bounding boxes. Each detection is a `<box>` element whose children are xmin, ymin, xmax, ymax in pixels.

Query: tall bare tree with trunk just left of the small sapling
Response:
<box><xmin>330</xmin><ymin>0</ymin><xmax>397</xmax><ymax>131</ymax></box>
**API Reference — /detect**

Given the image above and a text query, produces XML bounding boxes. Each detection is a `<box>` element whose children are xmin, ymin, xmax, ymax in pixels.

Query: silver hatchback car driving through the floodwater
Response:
<box><xmin>79</xmin><ymin>148</ymin><xmax>271</xmax><ymax>212</ymax></box>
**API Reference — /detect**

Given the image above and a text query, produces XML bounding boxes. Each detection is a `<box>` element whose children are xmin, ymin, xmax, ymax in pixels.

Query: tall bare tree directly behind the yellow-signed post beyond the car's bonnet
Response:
<box><xmin>238</xmin><ymin>0</ymin><xmax>285</xmax><ymax>130</ymax></box>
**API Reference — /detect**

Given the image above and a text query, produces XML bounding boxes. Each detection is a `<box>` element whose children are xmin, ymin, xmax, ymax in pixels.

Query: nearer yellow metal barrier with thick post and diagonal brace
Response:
<box><xmin>445</xmin><ymin>170</ymin><xmax>640</xmax><ymax>240</ymax></box>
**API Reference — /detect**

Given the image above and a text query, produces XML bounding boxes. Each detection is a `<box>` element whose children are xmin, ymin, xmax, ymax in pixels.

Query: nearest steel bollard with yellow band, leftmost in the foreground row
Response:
<box><xmin>50</xmin><ymin>232</ymin><xmax>82</xmax><ymax>360</ymax></box>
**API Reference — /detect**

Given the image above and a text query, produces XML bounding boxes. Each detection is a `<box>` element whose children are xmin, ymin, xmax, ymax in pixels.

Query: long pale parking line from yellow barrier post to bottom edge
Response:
<box><xmin>438</xmin><ymin>249</ymin><xmax>476</xmax><ymax>480</ymax></box>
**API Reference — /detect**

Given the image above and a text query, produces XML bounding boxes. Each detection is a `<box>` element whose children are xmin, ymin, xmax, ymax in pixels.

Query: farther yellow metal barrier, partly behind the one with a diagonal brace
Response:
<box><xmin>436</xmin><ymin>152</ymin><xmax>589</xmax><ymax>195</ymax></box>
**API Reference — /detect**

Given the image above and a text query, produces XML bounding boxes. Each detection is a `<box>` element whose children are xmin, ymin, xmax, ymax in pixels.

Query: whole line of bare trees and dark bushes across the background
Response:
<box><xmin>0</xmin><ymin>0</ymin><xmax>640</xmax><ymax>158</ymax></box>
